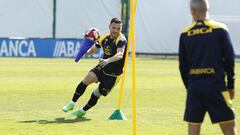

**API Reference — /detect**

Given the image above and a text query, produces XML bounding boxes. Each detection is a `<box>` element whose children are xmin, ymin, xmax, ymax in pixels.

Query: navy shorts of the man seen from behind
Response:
<box><xmin>184</xmin><ymin>78</ymin><xmax>235</xmax><ymax>123</ymax></box>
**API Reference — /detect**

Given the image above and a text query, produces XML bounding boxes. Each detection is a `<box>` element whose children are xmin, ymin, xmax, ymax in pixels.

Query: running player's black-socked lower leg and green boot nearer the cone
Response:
<box><xmin>72</xmin><ymin>90</ymin><xmax>101</xmax><ymax>117</ymax></box>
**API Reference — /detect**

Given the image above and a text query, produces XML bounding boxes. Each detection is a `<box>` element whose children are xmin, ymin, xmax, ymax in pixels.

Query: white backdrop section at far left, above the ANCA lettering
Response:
<box><xmin>0</xmin><ymin>0</ymin><xmax>53</xmax><ymax>37</ymax></box>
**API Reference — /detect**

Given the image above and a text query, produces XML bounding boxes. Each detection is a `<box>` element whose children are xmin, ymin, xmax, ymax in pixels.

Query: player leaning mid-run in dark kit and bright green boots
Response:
<box><xmin>62</xmin><ymin>18</ymin><xmax>127</xmax><ymax>117</ymax></box>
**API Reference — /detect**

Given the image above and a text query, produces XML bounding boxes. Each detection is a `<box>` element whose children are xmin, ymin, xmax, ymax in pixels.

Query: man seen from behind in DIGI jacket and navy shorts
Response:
<box><xmin>179</xmin><ymin>0</ymin><xmax>237</xmax><ymax>135</ymax></box>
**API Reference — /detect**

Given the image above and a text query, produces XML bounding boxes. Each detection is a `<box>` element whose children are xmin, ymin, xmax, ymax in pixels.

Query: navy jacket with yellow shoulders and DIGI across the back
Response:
<box><xmin>179</xmin><ymin>20</ymin><xmax>235</xmax><ymax>90</ymax></box>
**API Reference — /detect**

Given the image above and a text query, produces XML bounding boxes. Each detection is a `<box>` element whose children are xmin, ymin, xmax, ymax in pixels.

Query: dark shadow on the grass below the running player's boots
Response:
<box><xmin>19</xmin><ymin>117</ymin><xmax>91</xmax><ymax>124</ymax></box>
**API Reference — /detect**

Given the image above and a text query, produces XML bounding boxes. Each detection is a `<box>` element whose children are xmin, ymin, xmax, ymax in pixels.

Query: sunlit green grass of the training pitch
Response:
<box><xmin>0</xmin><ymin>58</ymin><xmax>240</xmax><ymax>135</ymax></box>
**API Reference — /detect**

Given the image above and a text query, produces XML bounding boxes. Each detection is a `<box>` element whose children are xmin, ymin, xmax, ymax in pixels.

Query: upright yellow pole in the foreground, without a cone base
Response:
<box><xmin>130</xmin><ymin>0</ymin><xmax>137</xmax><ymax>135</ymax></box>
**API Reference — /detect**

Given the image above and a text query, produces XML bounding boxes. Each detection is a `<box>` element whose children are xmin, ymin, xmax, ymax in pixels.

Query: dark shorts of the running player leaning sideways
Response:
<box><xmin>91</xmin><ymin>65</ymin><xmax>120</xmax><ymax>96</ymax></box>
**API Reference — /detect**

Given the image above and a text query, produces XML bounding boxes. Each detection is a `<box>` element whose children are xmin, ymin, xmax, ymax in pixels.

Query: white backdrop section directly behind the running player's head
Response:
<box><xmin>56</xmin><ymin>0</ymin><xmax>121</xmax><ymax>38</ymax></box>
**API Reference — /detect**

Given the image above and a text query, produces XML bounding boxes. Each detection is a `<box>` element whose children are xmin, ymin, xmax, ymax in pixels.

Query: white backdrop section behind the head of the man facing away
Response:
<box><xmin>135</xmin><ymin>0</ymin><xmax>240</xmax><ymax>55</ymax></box>
